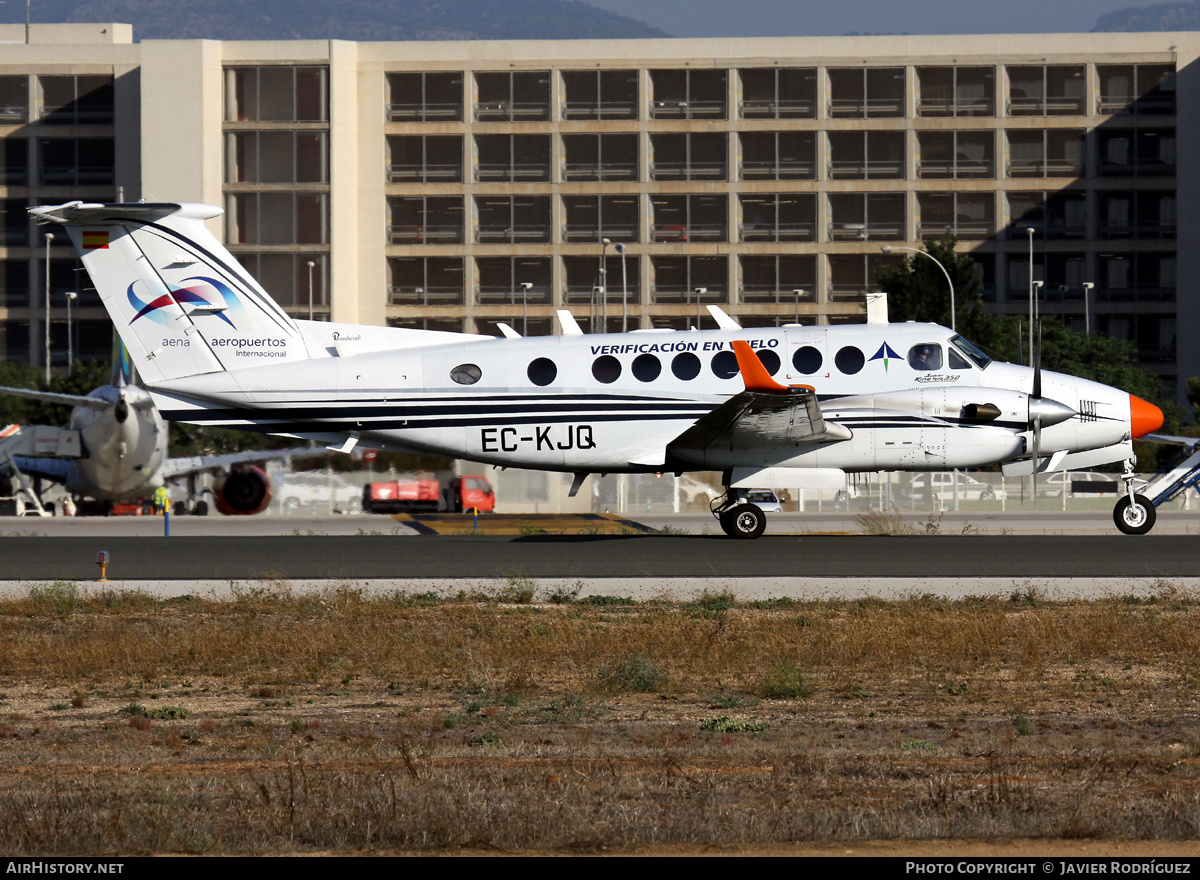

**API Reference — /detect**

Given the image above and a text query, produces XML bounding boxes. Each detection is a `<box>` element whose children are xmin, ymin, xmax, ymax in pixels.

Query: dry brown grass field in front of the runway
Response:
<box><xmin>0</xmin><ymin>579</ymin><xmax>1200</xmax><ymax>855</ymax></box>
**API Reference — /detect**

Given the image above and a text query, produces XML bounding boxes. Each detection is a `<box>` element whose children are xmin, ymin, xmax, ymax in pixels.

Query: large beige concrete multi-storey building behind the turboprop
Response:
<box><xmin>0</xmin><ymin>24</ymin><xmax>1200</xmax><ymax>400</ymax></box>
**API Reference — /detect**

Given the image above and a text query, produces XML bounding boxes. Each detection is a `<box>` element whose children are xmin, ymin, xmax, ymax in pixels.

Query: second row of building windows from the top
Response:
<box><xmin>381</xmin><ymin>127</ymin><xmax>1176</xmax><ymax>184</ymax></box>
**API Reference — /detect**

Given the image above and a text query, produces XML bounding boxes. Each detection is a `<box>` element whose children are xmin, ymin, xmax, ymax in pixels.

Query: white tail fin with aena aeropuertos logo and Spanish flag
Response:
<box><xmin>30</xmin><ymin>202</ymin><xmax>308</xmax><ymax>385</ymax></box>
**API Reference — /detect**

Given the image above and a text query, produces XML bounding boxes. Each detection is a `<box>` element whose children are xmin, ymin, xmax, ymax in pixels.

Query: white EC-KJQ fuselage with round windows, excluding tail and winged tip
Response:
<box><xmin>154</xmin><ymin>322</ymin><xmax>1130</xmax><ymax>472</ymax></box>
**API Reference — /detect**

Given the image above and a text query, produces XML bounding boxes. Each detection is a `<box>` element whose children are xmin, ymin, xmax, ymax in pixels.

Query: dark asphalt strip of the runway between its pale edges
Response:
<box><xmin>0</xmin><ymin>535</ymin><xmax>1200</xmax><ymax>581</ymax></box>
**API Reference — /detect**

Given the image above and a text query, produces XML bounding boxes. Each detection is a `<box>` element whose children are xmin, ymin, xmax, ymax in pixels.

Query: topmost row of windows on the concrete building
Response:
<box><xmin>381</xmin><ymin>64</ymin><xmax>1176</xmax><ymax>122</ymax></box>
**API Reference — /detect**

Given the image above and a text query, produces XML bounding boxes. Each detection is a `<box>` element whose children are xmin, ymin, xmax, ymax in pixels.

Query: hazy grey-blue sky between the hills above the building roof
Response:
<box><xmin>587</xmin><ymin>0</ymin><xmax>1163</xmax><ymax>37</ymax></box>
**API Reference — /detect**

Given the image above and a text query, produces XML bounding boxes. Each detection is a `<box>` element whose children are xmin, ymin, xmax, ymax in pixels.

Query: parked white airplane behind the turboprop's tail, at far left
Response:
<box><xmin>0</xmin><ymin>372</ymin><xmax>309</xmax><ymax>515</ymax></box>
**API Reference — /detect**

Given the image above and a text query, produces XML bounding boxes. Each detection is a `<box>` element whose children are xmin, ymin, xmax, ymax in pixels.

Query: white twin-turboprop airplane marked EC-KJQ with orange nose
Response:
<box><xmin>30</xmin><ymin>202</ymin><xmax>1163</xmax><ymax>538</ymax></box>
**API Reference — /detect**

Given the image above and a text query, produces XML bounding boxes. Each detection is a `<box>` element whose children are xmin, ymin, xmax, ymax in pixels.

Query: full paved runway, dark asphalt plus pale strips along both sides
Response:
<box><xmin>0</xmin><ymin>511</ymin><xmax>1200</xmax><ymax>598</ymax></box>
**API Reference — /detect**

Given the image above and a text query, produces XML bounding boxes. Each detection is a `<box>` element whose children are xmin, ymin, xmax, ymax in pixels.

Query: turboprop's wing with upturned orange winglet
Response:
<box><xmin>670</xmin><ymin>342</ymin><xmax>851</xmax><ymax>451</ymax></box>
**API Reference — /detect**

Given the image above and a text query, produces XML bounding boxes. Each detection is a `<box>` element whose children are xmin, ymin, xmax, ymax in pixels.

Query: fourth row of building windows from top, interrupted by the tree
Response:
<box><xmin>381</xmin><ymin>251</ymin><xmax>1177</xmax><ymax>313</ymax></box>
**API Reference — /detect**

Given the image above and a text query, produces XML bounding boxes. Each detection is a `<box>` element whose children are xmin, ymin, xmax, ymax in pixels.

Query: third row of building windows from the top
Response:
<box><xmin>381</xmin><ymin>190</ymin><xmax>1177</xmax><ymax>246</ymax></box>
